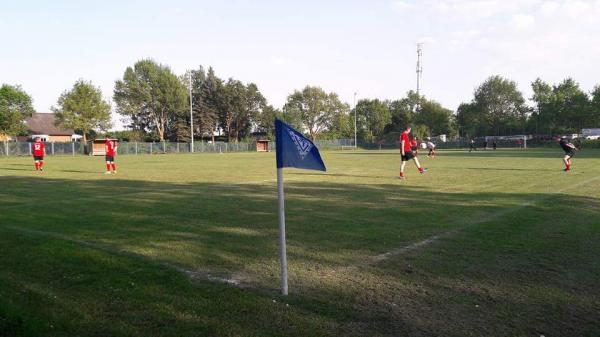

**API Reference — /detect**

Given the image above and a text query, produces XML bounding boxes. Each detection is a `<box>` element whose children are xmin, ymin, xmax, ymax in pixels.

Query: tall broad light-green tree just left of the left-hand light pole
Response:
<box><xmin>114</xmin><ymin>60</ymin><xmax>189</xmax><ymax>141</ymax></box>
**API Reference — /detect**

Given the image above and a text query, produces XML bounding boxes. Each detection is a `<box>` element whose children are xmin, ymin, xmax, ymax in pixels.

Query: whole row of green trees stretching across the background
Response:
<box><xmin>0</xmin><ymin>59</ymin><xmax>600</xmax><ymax>143</ymax></box>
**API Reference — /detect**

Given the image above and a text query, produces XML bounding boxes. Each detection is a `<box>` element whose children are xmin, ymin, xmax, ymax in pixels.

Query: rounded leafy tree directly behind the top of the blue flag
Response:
<box><xmin>284</xmin><ymin>86</ymin><xmax>349</xmax><ymax>140</ymax></box>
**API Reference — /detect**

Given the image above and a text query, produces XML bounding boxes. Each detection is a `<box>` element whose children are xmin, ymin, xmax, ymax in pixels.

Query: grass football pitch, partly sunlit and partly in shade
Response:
<box><xmin>0</xmin><ymin>149</ymin><xmax>600</xmax><ymax>337</ymax></box>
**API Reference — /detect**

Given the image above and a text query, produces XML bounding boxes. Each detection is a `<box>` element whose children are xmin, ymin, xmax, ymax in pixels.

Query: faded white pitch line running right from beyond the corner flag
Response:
<box><xmin>367</xmin><ymin>176</ymin><xmax>600</xmax><ymax>265</ymax></box>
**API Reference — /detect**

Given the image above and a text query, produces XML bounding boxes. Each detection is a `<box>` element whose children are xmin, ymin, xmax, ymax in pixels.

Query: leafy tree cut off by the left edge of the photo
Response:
<box><xmin>0</xmin><ymin>84</ymin><xmax>34</xmax><ymax>135</ymax></box>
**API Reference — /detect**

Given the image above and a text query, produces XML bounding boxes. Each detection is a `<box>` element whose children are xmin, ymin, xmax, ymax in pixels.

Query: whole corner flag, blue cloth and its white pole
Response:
<box><xmin>275</xmin><ymin>119</ymin><xmax>326</xmax><ymax>295</ymax></box>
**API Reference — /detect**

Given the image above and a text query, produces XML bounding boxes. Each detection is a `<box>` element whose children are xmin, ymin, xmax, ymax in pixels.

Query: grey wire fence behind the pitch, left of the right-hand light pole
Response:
<box><xmin>0</xmin><ymin>139</ymin><xmax>354</xmax><ymax>157</ymax></box>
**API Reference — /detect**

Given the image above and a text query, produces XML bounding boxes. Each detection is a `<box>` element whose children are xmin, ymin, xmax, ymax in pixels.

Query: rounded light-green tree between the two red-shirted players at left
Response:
<box><xmin>52</xmin><ymin>79</ymin><xmax>111</xmax><ymax>143</ymax></box>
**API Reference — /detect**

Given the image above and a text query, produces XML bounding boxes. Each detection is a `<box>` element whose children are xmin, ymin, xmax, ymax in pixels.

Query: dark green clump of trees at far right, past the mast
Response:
<box><xmin>456</xmin><ymin>76</ymin><xmax>600</xmax><ymax>137</ymax></box>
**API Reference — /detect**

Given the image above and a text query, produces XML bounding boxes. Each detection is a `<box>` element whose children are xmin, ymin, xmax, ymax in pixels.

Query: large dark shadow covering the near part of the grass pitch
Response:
<box><xmin>0</xmin><ymin>173</ymin><xmax>600</xmax><ymax>336</ymax></box>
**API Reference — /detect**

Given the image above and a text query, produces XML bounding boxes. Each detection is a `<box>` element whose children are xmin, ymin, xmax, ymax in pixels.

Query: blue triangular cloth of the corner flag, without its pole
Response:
<box><xmin>275</xmin><ymin>119</ymin><xmax>326</xmax><ymax>171</ymax></box>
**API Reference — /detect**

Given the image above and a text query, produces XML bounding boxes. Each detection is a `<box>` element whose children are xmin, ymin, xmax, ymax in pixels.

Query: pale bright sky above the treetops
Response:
<box><xmin>0</xmin><ymin>0</ymin><xmax>600</xmax><ymax>129</ymax></box>
